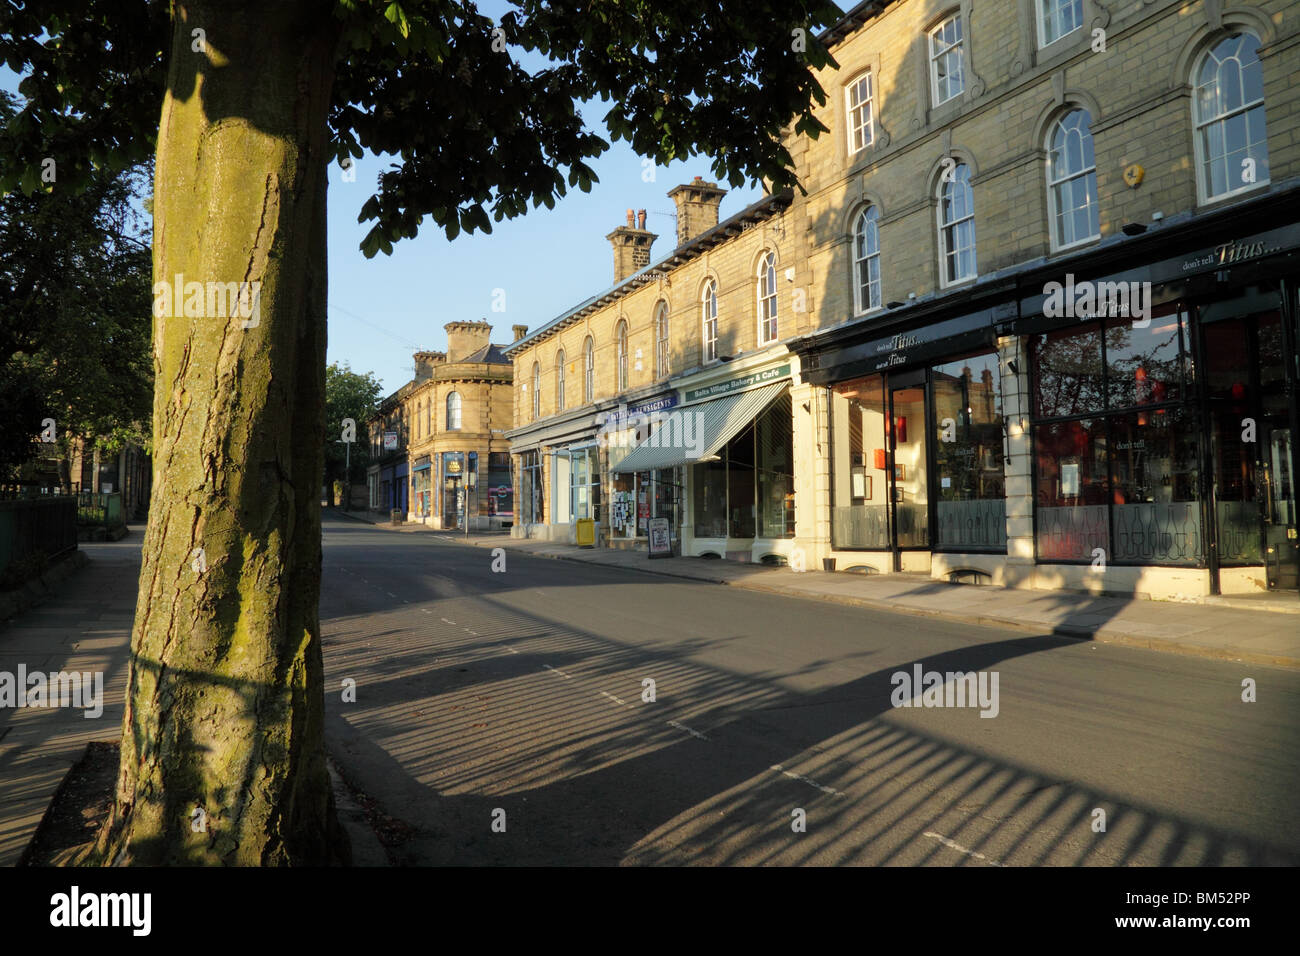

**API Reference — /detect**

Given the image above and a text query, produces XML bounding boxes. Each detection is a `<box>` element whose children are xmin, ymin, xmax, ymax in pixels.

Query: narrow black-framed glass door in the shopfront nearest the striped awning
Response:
<box><xmin>885</xmin><ymin>369</ymin><xmax>930</xmax><ymax>571</ymax></box>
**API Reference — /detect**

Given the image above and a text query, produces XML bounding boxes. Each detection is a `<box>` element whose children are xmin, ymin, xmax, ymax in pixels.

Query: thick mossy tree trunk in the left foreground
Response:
<box><xmin>87</xmin><ymin>0</ymin><xmax>348</xmax><ymax>865</ymax></box>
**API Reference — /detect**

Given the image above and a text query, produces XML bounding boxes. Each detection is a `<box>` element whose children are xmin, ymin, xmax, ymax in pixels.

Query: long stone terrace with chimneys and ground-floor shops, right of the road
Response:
<box><xmin>507</xmin><ymin>0</ymin><xmax>1300</xmax><ymax>597</ymax></box>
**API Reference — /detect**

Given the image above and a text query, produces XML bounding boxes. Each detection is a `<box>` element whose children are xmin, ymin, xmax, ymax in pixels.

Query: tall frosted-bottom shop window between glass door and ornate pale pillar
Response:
<box><xmin>931</xmin><ymin>352</ymin><xmax>1006</xmax><ymax>551</ymax></box>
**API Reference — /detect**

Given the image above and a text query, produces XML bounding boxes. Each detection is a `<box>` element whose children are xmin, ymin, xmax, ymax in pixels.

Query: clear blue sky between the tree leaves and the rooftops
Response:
<box><xmin>0</xmin><ymin>0</ymin><xmax>845</xmax><ymax>393</ymax></box>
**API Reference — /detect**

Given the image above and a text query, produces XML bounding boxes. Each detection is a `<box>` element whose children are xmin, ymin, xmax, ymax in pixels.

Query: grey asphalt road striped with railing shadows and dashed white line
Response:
<box><xmin>321</xmin><ymin>519</ymin><xmax>1300</xmax><ymax>866</ymax></box>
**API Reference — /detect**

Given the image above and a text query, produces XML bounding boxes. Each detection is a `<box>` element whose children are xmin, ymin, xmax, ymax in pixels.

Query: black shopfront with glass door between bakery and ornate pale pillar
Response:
<box><xmin>806</xmin><ymin>304</ymin><xmax>1008</xmax><ymax>575</ymax></box>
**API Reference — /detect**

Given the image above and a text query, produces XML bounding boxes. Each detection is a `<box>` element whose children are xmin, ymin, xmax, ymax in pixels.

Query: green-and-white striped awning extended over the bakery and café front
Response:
<box><xmin>610</xmin><ymin>381</ymin><xmax>789</xmax><ymax>473</ymax></box>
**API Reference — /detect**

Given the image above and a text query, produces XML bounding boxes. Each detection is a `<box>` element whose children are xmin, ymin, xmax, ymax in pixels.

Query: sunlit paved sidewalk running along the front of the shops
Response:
<box><xmin>339</xmin><ymin>512</ymin><xmax>1300</xmax><ymax>669</ymax></box>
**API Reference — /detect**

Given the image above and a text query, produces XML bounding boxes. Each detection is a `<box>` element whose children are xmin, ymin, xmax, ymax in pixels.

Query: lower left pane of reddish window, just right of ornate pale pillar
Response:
<box><xmin>1034</xmin><ymin>419</ymin><xmax>1110</xmax><ymax>561</ymax></box>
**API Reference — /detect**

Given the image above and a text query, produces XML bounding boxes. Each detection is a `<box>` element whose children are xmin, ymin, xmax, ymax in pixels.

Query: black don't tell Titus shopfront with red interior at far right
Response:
<box><xmin>1017</xmin><ymin>225</ymin><xmax>1300</xmax><ymax>596</ymax></box>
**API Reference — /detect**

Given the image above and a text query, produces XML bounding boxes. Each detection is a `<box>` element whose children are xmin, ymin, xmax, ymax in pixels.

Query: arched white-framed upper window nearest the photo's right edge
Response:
<box><xmin>1192</xmin><ymin>33</ymin><xmax>1269</xmax><ymax>199</ymax></box>
